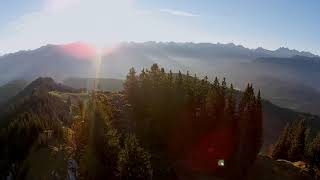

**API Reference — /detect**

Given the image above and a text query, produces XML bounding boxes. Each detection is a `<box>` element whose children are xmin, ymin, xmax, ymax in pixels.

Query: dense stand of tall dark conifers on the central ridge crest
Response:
<box><xmin>125</xmin><ymin>65</ymin><xmax>262</xmax><ymax>179</ymax></box>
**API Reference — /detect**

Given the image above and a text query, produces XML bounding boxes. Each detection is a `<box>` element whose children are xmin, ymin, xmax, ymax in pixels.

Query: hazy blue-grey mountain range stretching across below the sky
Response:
<box><xmin>0</xmin><ymin>42</ymin><xmax>320</xmax><ymax>115</ymax></box>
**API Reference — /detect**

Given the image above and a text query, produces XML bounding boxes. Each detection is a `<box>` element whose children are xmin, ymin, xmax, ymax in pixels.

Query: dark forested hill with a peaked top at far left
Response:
<box><xmin>0</xmin><ymin>78</ymin><xmax>72</xmax><ymax>179</ymax></box>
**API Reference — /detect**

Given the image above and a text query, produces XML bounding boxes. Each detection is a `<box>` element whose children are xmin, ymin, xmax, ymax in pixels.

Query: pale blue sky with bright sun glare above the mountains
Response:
<box><xmin>0</xmin><ymin>0</ymin><xmax>320</xmax><ymax>55</ymax></box>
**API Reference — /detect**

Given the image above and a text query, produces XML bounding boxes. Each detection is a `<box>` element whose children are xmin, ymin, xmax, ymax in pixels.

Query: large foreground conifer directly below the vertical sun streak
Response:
<box><xmin>74</xmin><ymin>97</ymin><xmax>120</xmax><ymax>179</ymax></box>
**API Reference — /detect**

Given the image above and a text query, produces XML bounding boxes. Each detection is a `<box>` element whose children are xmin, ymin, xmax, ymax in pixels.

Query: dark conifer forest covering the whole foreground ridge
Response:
<box><xmin>7</xmin><ymin>64</ymin><xmax>319</xmax><ymax>179</ymax></box>
